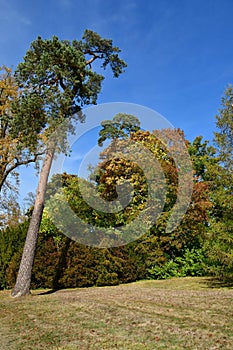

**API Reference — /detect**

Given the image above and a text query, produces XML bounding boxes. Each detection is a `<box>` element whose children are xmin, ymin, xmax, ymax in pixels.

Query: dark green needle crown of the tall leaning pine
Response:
<box><xmin>14</xmin><ymin>30</ymin><xmax>126</xmax><ymax>151</ymax></box>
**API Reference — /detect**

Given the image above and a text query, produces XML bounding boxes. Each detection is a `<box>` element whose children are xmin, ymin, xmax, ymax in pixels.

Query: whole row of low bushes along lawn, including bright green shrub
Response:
<box><xmin>0</xmin><ymin>217</ymin><xmax>208</xmax><ymax>289</ymax></box>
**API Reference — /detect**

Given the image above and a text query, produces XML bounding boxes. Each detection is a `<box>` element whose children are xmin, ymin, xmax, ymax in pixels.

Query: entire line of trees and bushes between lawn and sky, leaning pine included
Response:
<box><xmin>0</xmin><ymin>30</ymin><xmax>233</xmax><ymax>296</ymax></box>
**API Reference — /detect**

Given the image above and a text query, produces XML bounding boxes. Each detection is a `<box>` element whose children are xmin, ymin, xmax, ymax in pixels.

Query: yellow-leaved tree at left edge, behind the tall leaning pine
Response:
<box><xmin>0</xmin><ymin>66</ymin><xmax>40</xmax><ymax>227</ymax></box>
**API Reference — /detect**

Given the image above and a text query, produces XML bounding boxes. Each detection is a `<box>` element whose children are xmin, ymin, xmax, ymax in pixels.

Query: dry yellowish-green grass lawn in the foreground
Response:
<box><xmin>0</xmin><ymin>278</ymin><xmax>233</xmax><ymax>350</ymax></box>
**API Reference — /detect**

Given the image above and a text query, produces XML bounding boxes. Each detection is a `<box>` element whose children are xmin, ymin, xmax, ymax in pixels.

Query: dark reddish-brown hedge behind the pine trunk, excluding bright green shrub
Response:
<box><xmin>0</xmin><ymin>215</ymin><xmax>146</xmax><ymax>289</ymax></box>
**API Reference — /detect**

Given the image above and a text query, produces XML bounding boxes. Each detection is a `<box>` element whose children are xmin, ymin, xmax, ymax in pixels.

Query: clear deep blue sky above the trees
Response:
<box><xmin>0</xmin><ymin>0</ymin><xmax>233</xmax><ymax>204</ymax></box>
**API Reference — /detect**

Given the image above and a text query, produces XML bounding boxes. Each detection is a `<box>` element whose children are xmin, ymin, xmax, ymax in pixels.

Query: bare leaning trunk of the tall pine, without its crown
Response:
<box><xmin>11</xmin><ymin>149</ymin><xmax>54</xmax><ymax>297</ymax></box>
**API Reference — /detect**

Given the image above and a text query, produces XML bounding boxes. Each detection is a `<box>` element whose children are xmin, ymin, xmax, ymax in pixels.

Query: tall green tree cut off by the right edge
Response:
<box><xmin>209</xmin><ymin>87</ymin><xmax>233</xmax><ymax>278</ymax></box>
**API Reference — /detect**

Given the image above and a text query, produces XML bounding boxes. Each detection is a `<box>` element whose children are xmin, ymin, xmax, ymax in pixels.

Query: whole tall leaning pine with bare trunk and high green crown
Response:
<box><xmin>12</xmin><ymin>30</ymin><xmax>126</xmax><ymax>296</ymax></box>
